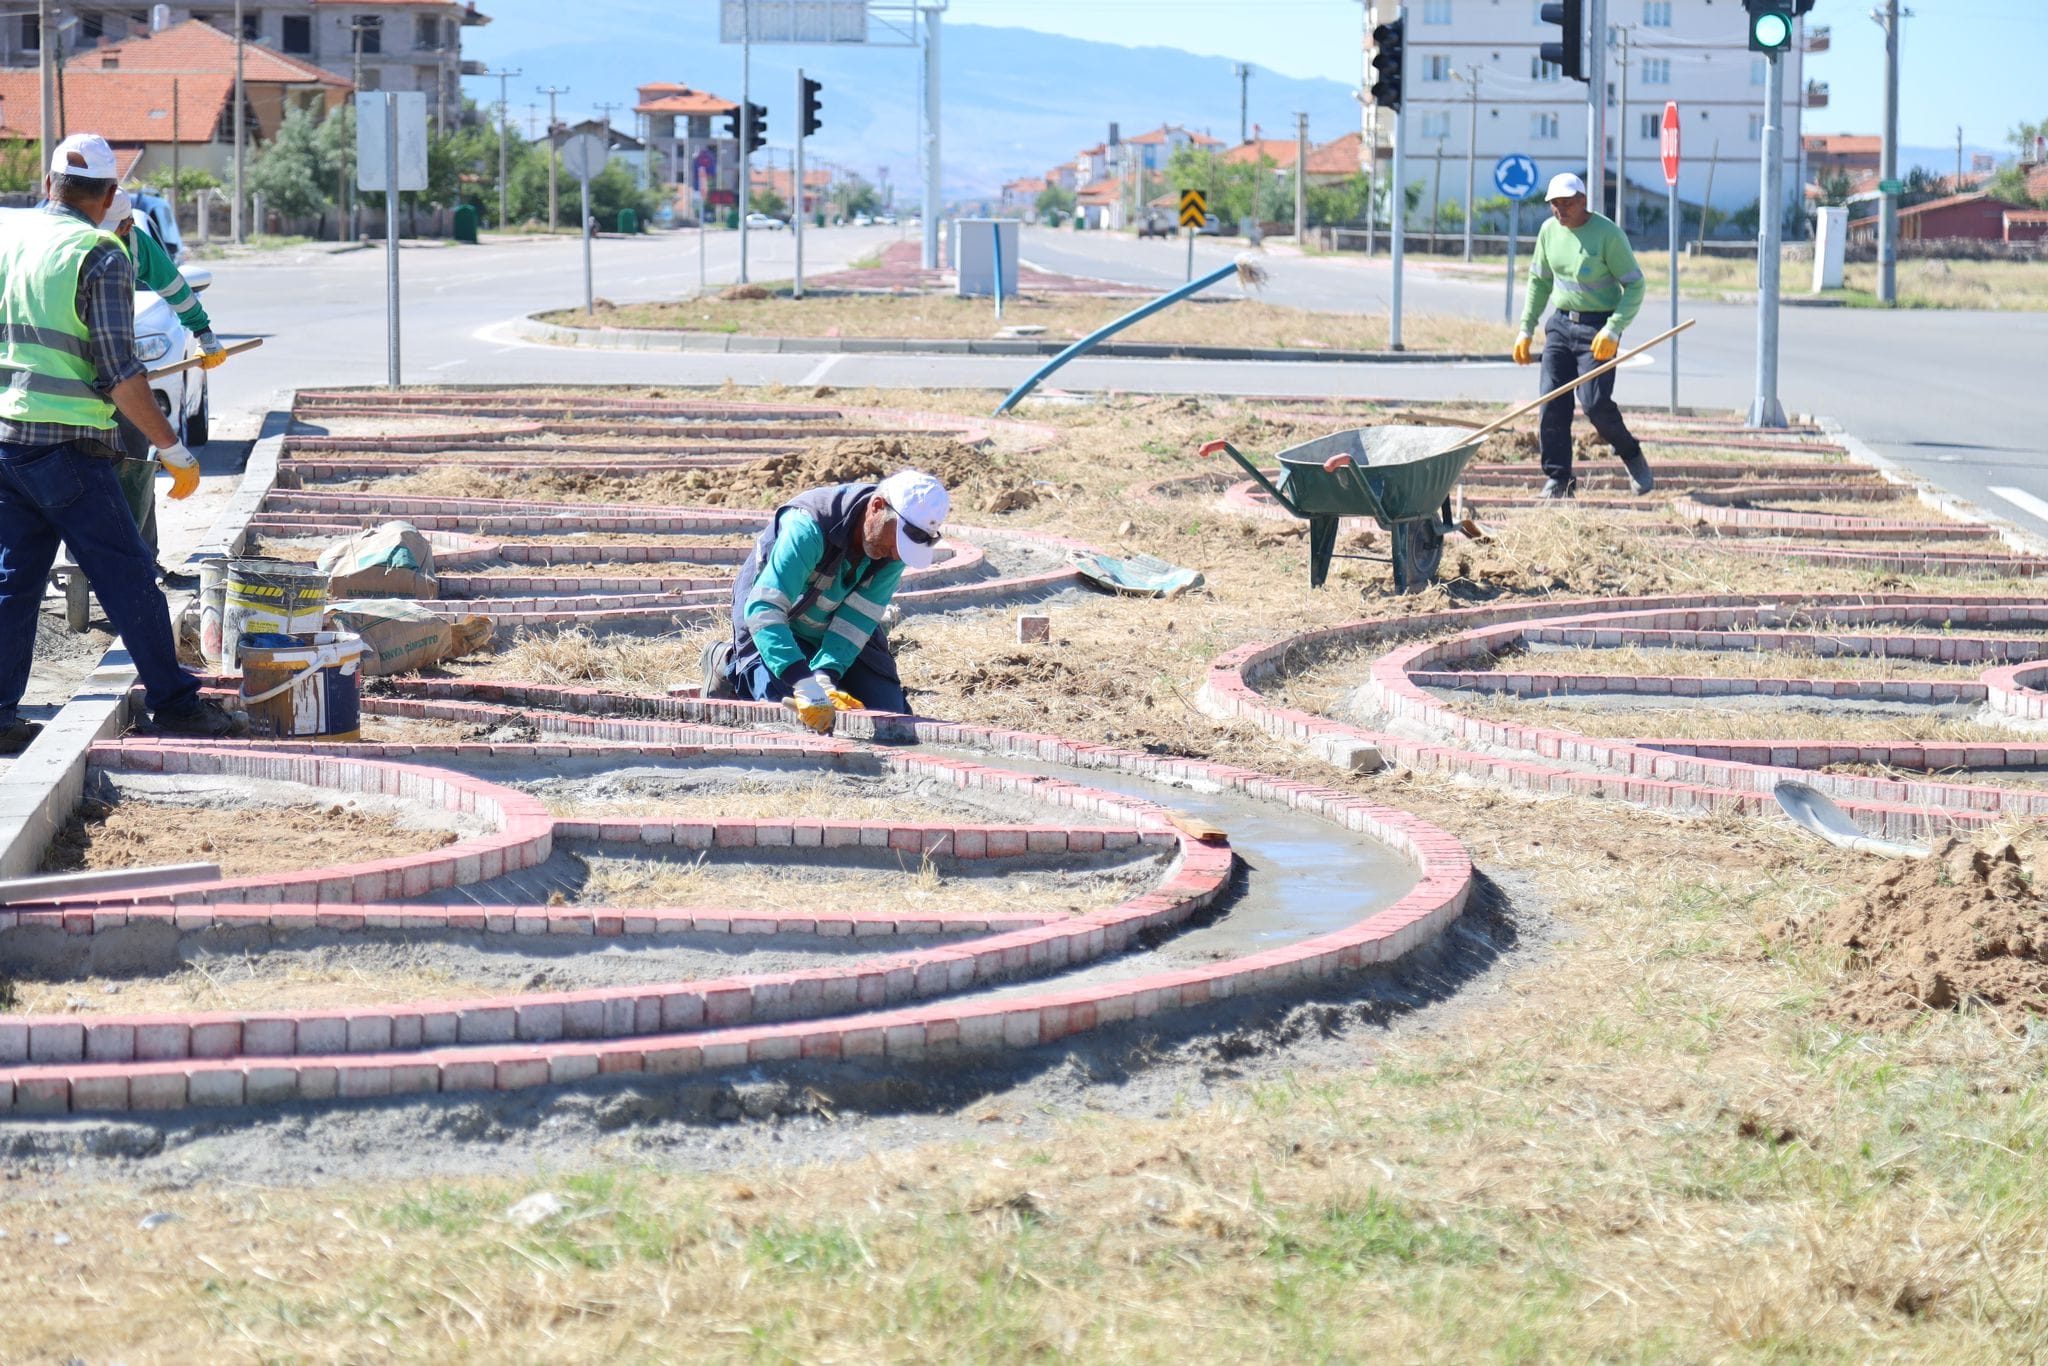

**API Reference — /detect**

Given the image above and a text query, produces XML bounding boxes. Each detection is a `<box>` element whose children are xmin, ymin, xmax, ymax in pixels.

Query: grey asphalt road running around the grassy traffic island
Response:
<box><xmin>188</xmin><ymin>227</ymin><xmax>2048</xmax><ymax>535</ymax></box>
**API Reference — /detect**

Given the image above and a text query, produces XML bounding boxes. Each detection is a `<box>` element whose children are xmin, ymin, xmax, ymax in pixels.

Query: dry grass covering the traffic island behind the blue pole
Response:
<box><xmin>543</xmin><ymin>291</ymin><xmax>1516</xmax><ymax>352</ymax></box>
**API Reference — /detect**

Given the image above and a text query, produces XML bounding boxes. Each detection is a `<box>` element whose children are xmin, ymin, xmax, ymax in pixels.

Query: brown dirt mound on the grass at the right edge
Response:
<box><xmin>1780</xmin><ymin>827</ymin><xmax>2048</xmax><ymax>1026</ymax></box>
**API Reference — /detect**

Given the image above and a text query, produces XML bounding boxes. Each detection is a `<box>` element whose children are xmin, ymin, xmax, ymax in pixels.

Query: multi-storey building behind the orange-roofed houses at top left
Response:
<box><xmin>0</xmin><ymin>0</ymin><xmax>489</xmax><ymax>127</ymax></box>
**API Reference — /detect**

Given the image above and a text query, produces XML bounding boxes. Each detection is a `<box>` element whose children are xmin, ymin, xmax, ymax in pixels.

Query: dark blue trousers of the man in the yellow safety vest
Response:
<box><xmin>0</xmin><ymin>442</ymin><xmax>199</xmax><ymax>725</ymax></box>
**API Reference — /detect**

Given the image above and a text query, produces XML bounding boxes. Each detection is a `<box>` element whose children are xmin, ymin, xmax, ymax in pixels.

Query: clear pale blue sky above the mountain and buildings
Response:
<box><xmin>946</xmin><ymin>0</ymin><xmax>2048</xmax><ymax>147</ymax></box>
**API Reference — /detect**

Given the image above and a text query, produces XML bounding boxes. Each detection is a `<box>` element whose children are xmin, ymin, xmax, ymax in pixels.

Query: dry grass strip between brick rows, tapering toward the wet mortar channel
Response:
<box><xmin>575</xmin><ymin>850</ymin><xmax>1157</xmax><ymax>913</ymax></box>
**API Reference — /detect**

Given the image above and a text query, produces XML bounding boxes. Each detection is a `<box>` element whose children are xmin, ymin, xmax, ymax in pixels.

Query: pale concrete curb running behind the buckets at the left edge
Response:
<box><xmin>0</xmin><ymin>405</ymin><xmax>291</xmax><ymax>877</ymax></box>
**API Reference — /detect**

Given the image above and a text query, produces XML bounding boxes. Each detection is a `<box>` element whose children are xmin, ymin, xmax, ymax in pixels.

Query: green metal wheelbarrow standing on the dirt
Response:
<box><xmin>1202</xmin><ymin>426</ymin><xmax>1483</xmax><ymax>594</ymax></box>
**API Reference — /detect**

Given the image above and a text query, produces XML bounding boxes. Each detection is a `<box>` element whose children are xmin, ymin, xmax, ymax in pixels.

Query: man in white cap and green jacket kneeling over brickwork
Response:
<box><xmin>698</xmin><ymin>469</ymin><xmax>952</xmax><ymax>735</ymax></box>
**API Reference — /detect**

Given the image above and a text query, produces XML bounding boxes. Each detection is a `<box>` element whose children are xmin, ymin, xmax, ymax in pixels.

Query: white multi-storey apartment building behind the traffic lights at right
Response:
<box><xmin>1364</xmin><ymin>0</ymin><xmax>1827</xmax><ymax>229</ymax></box>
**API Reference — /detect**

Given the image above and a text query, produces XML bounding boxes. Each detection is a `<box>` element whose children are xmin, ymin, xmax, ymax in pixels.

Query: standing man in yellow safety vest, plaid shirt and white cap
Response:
<box><xmin>0</xmin><ymin>133</ymin><xmax>246</xmax><ymax>754</ymax></box>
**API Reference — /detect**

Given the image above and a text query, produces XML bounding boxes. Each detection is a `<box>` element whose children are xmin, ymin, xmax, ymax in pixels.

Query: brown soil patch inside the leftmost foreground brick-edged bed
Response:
<box><xmin>41</xmin><ymin>797</ymin><xmax>457</xmax><ymax>877</ymax></box>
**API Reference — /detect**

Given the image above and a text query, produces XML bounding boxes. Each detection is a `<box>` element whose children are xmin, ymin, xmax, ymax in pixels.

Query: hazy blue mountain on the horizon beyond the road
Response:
<box><xmin>463</xmin><ymin>0</ymin><xmax>1358</xmax><ymax>201</ymax></box>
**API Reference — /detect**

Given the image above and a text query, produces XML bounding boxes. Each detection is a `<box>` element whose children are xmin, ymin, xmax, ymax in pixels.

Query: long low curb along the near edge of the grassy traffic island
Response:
<box><xmin>512</xmin><ymin>315</ymin><xmax>1509</xmax><ymax>365</ymax></box>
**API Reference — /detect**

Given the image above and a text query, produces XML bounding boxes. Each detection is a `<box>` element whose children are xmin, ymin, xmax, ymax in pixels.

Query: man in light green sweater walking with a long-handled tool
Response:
<box><xmin>1513</xmin><ymin>172</ymin><xmax>1657</xmax><ymax>498</ymax></box>
